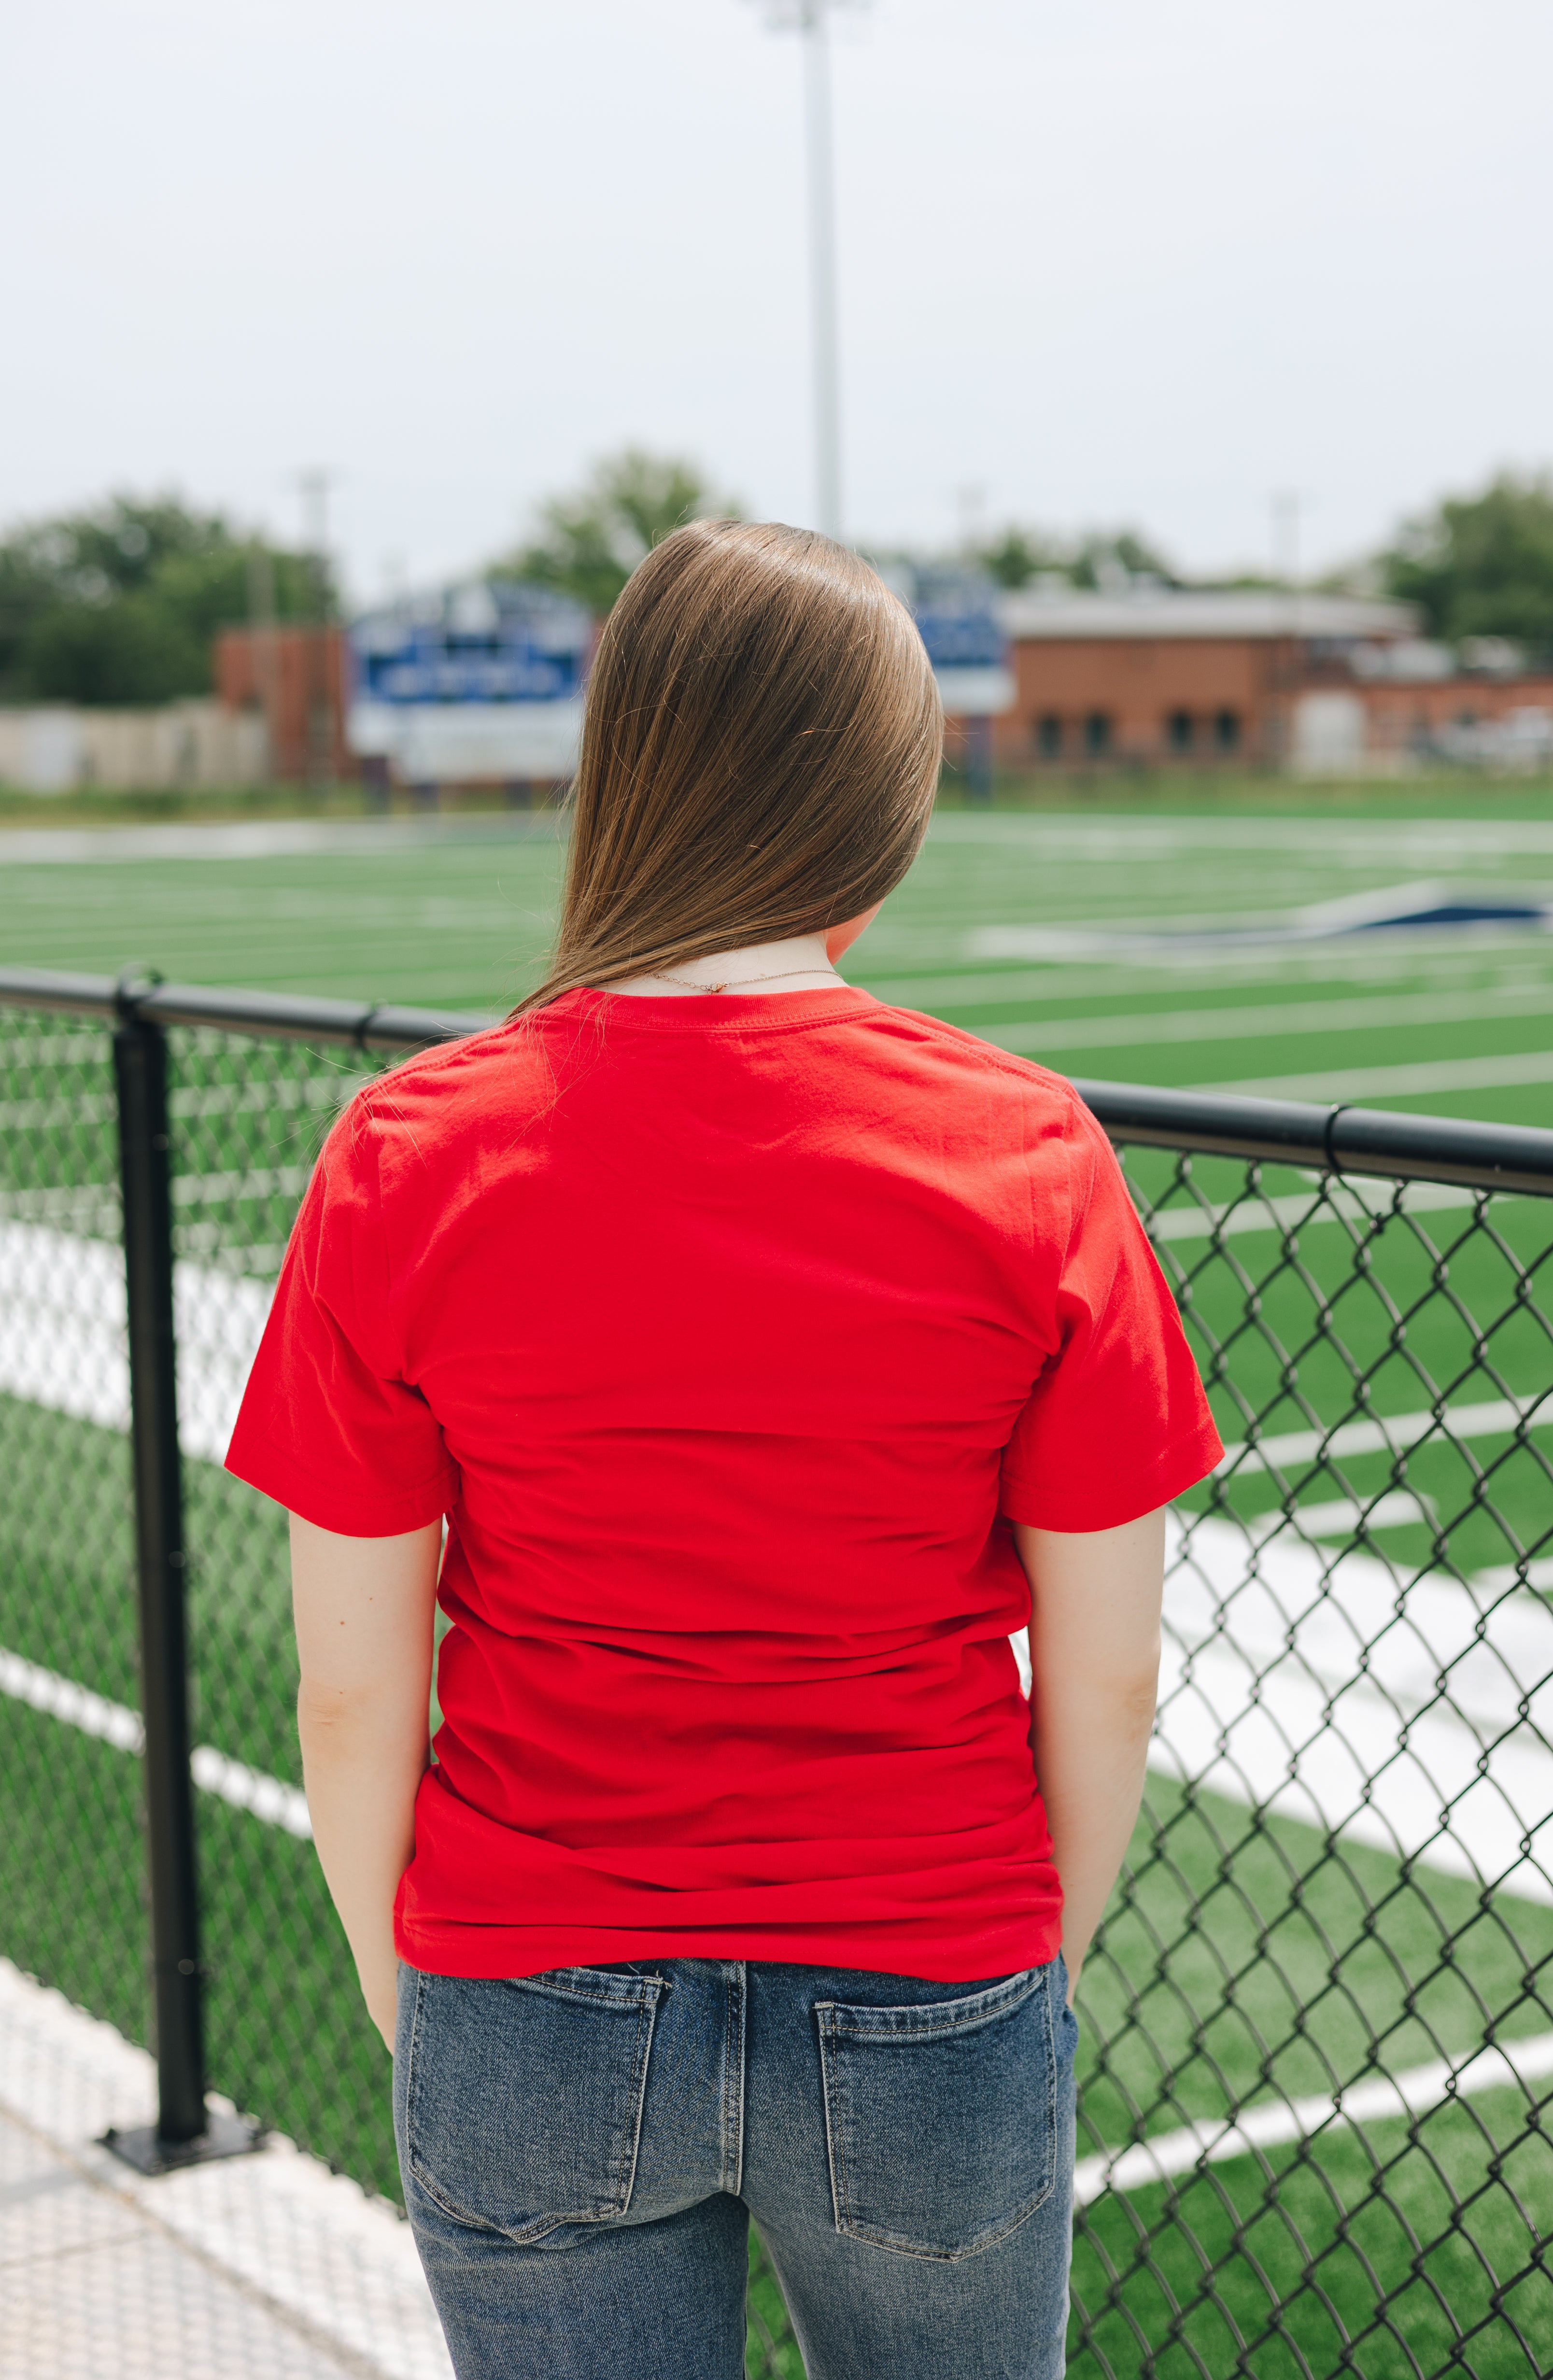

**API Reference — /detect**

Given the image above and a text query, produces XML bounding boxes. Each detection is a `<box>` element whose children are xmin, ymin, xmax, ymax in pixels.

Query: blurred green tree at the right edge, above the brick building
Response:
<box><xmin>1379</xmin><ymin>471</ymin><xmax>1553</xmax><ymax>650</ymax></box>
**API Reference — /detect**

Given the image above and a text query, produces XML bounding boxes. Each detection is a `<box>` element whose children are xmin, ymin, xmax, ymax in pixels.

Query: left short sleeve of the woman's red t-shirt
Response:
<box><xmin>226</xmin><ymin>1099</ymin><xmax>457</xmax><ymax>1537</ymax></box>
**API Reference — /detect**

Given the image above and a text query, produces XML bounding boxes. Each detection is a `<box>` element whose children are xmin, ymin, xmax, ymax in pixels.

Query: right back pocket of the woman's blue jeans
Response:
<box><xmin>815</xmin><ymin>1966</ymin><xmax>1060</xmax><ymax>2259</ymax></box>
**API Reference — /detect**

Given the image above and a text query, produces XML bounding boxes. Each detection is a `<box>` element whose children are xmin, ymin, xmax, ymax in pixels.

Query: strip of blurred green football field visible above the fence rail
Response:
<box><xmin>0</xmin><ymin>795</ymin><xmax>1553</xmax><ymax>1123</ymax></box>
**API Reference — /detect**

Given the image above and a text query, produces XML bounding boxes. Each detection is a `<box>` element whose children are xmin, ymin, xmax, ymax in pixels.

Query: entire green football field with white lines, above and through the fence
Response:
<box><xmin>0</xmin><ymin>792</ymin><xmax>1553</xmax><ymax>2380</ymax></box>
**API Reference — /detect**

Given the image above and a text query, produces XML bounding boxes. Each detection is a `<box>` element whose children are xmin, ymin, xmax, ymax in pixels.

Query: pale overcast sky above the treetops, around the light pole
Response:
<box><xmin>12</xmin><ymin>0</ymin><xmax>1553</xmax><ymax>597</ymax></box>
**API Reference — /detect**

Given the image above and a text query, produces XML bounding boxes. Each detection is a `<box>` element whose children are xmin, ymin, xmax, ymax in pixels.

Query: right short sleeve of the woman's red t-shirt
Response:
<box><xmin>1001</xmin><ymin>1109</ymin><xmax>1224</xmax><ymax>1530</ymax></box>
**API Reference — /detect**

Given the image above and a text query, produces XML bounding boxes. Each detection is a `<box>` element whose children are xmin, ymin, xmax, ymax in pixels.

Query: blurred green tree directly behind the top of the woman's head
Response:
<box><xmin>495</xmin><ymin>448</ymin><xmax>738</xmax><ymax>614</ymax></box>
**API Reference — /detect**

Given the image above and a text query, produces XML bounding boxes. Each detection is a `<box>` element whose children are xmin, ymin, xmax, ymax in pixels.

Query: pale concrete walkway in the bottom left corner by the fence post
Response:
<box><xmin>0</xmin><ymin>1961</ymin><xmax>452</xmax><ymax>2380</ymax></box>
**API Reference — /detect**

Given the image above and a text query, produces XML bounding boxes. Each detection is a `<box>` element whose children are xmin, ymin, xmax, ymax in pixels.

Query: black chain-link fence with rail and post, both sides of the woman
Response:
<box><xmin>0</xmin><ymin>971</ymin><xmax>1553</xmax><ymax>2380</ymax></box>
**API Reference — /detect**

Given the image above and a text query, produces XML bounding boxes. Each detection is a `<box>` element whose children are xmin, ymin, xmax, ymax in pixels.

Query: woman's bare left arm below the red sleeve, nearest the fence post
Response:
<box><xmin>291</xmin><ymin>1514</ymin><xmax>443</xmax><ymax>2049</ymax></box>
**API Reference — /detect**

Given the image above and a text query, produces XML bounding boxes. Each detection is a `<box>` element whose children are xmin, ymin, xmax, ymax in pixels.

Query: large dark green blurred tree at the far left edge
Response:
<box><xmin>0</xmin><ymin>495</ymin><xmax>329</xmax><ymax>704</ymax></box>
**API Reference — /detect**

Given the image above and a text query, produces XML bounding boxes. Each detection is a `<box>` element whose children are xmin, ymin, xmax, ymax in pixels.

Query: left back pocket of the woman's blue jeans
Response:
<box><xmin>395</xmin><ymin>1966</ymin><xmax>669</xmax><ymax>2247</ymax></box>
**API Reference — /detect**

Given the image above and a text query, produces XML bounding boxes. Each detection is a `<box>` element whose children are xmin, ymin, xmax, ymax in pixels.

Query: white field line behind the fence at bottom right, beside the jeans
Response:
<box><xmin>1074</xmin><ymin>2032</ymin><xmax>1553</xmax><ymax>2206</ymax></box>
